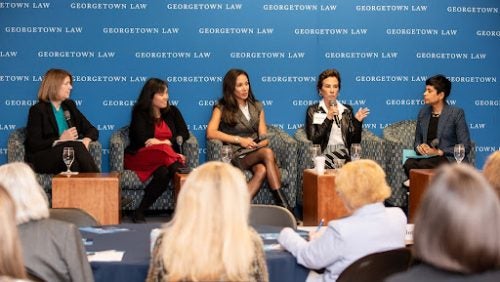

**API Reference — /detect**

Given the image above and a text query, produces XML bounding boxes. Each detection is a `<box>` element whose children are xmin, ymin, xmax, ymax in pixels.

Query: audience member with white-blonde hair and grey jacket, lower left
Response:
<box><xmin>0</xmin><ymin>162</ymin><xmax>94</xmax><ymax>282</ymax></box>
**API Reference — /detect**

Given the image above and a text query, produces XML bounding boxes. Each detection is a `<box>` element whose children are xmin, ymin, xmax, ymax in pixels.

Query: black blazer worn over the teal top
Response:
<box><xmin>24</xmin><ymin>99</ymin><xmax>99</xmax><ymax>160</ymax></box>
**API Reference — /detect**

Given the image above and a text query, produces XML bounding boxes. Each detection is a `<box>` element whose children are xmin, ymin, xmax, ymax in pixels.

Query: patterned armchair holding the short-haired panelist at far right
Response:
<box><xmin>382</xmin><ymin>120</ymin><xmax>476</xmax><ymax>207</ymax></box>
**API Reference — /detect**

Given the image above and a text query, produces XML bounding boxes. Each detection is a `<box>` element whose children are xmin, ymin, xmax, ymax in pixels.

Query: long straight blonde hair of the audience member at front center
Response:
<box><xmin>160</xmin><ymin>162</ymin><xmax>256</xmax><ymax>281</ymax></box>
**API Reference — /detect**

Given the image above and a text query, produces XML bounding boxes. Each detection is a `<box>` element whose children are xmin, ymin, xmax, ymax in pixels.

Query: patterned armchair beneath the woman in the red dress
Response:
<box><xmin>109</xmin><ymin>126</ymin><xmax>199</xmax><ymax>210</ymax></box>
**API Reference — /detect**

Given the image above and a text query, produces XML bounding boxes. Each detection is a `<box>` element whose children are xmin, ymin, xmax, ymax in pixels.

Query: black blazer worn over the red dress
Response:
<box><xmin>125</xmin><ymin>106</ymin><xmax>189</xmax><ymax>154</ymax></box>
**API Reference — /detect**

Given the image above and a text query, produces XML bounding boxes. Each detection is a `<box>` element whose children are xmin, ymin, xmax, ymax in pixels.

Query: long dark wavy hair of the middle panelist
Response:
<box><xmin>219</xmin><ymin>69</ymin><xmax>257</xmax><ymax>125</ymax></box>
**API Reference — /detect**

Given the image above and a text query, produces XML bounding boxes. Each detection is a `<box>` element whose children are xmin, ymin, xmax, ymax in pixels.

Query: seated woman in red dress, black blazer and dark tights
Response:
<box><xmin>124</xmin><ymin>78</ymin><xmax>189</xmax><ymax>222</ymax></box>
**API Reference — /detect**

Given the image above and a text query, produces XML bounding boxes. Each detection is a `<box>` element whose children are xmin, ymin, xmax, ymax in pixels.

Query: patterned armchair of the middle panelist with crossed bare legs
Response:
<box><xmin>207</xmin><ymin>125</ymin><xmax>297</xmax><ymax>207</ymax></box>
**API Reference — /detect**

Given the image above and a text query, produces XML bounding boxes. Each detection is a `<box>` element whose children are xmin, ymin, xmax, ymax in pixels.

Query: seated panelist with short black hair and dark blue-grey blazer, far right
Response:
<box><xmin>403</xmin><ymin>74</ymin><xmax>471</xmax><ymax>187</ymax></box>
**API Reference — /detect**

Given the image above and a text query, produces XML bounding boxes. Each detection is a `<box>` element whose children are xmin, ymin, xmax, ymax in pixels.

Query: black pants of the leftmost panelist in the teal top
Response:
<box><xmin>27</xmin><ymin>141</ymin><xmax>99</xmax><ymax>174</ymax></box>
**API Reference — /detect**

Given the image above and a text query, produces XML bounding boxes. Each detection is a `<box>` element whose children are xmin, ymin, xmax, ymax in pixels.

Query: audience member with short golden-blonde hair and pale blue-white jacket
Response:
<box><xmin>278</xmin><ymin>160</ymin><xmax>406</xmax><ymax>281</ymax></box>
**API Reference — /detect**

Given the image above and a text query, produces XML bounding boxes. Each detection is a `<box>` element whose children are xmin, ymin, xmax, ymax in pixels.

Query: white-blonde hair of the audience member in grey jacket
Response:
<box><xmin>0</xmin><ymin>162</ymin><xmax>49</xmax><ymax>224</ymax></box>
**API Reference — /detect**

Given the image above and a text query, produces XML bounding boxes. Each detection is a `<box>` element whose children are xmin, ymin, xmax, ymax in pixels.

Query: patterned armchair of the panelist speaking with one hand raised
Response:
<box><xmin>294</xmin><ymin>127</ymin><xmax>385</xmax><ymax>204</ymax></box>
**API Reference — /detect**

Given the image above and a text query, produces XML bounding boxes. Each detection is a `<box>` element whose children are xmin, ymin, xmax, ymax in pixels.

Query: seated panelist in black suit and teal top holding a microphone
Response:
<box><xmin>25</xmin><ymin>69</ymin><xmax>99</xmax><ymax>174</ymax></box>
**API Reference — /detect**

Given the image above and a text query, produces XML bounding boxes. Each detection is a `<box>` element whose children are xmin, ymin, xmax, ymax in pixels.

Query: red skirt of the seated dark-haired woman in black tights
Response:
<box><xmin>124</xmin><ymin>144</ymin><xmax>182</xmax><ymax>182</ymax></box>
